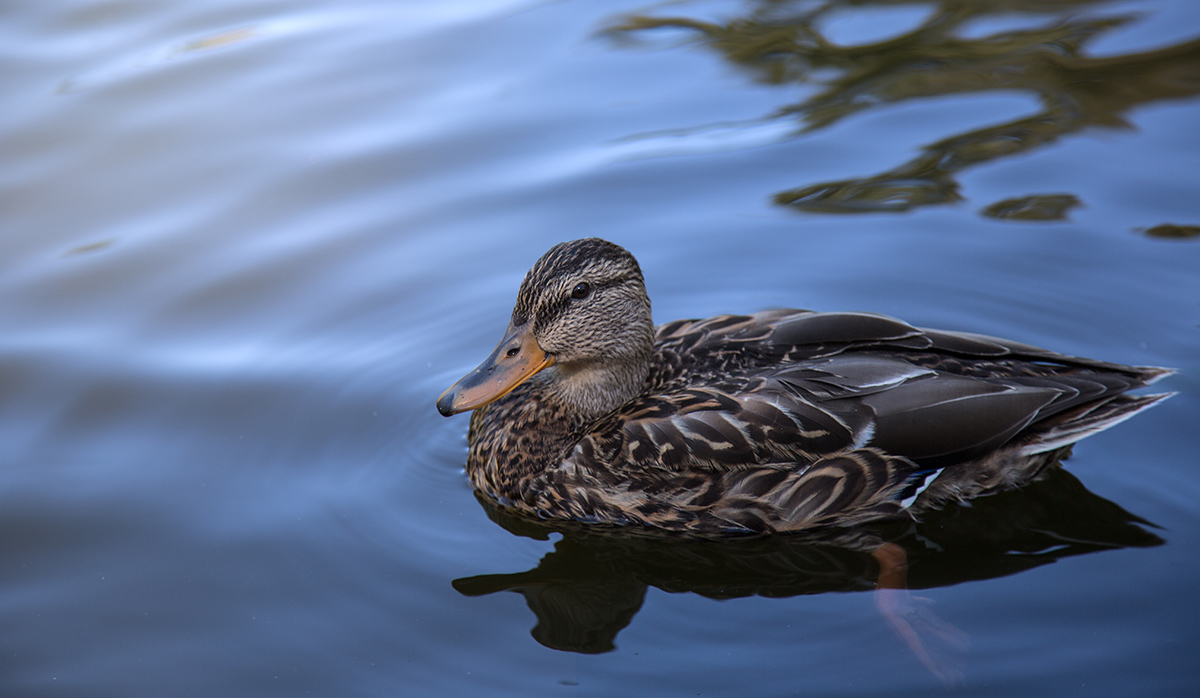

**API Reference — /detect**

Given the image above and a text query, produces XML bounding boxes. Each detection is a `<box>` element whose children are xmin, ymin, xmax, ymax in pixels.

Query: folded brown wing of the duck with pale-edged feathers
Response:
<box><xmin>590</xmin><ymin>311</ymin><xmax>1170</xmax><ymax>470</ymax></box>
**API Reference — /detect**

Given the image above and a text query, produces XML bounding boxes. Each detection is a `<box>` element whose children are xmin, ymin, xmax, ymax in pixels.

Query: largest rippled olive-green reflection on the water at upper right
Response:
<box><xmin>611</xmin><ymin>0</ymin><xmax>1200</xmax><ymax>214</ymax></box>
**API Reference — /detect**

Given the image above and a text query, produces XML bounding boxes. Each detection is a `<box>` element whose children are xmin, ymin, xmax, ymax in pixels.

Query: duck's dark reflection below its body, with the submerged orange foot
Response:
<box><xmin>454</xmin><ymin>468</ymin><xmax>1163</xmax><ymax>684</ymax></box>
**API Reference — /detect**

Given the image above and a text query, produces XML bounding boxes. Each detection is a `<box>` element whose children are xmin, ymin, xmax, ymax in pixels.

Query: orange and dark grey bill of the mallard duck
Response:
<box><xmin>438</xmin><ymin>323</ymin><xmax>554</xmax><ymax>417</ymax></box>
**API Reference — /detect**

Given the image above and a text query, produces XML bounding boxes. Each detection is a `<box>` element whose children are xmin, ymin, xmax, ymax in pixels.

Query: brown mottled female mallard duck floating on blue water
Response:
<box><xmin>438</xmin><ymin>239</ymin><xmax>1171</xmax><ymax>535</ymax></box>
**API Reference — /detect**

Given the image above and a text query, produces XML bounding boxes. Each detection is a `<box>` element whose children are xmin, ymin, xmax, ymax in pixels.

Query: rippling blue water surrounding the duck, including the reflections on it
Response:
<box><xmin>0</xmin><ymin>0</ymin><xmax>1200</xmax><ymax>697</ymax></box>
